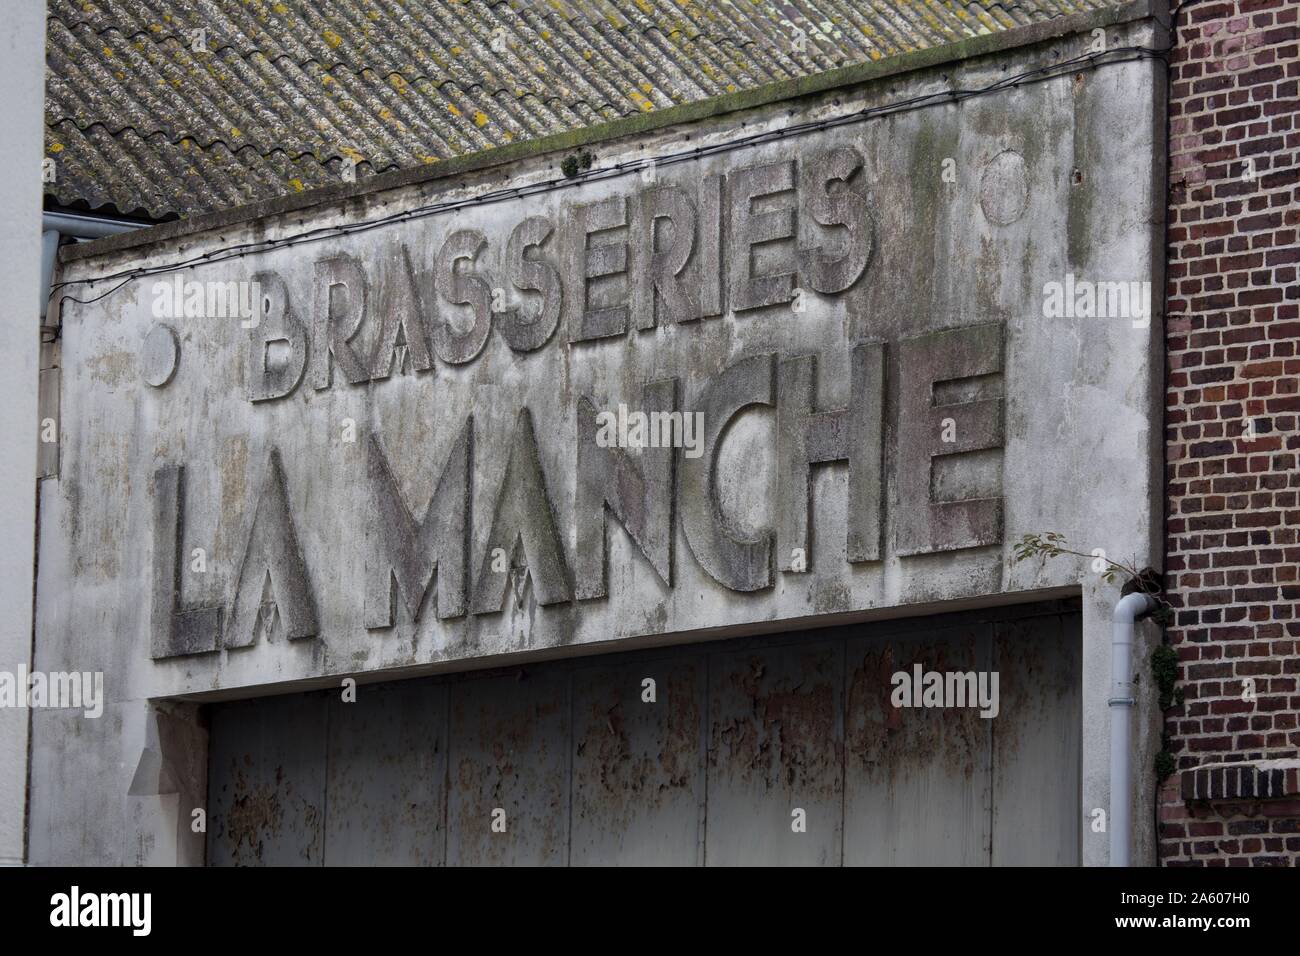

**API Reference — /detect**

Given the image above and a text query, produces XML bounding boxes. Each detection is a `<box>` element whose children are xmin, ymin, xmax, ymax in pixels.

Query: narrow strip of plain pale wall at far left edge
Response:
<box><xmin>0</xmin><ymin>3</ymin><xmax>46</xmax><ymax>864</ymax></box>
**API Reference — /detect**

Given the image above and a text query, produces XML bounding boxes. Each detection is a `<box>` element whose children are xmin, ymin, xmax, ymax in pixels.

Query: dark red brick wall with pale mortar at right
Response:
<box><xmin>1160</xmin><ymin>0</ymin><xmax>1300</xmax><ymax>866</ymax></box>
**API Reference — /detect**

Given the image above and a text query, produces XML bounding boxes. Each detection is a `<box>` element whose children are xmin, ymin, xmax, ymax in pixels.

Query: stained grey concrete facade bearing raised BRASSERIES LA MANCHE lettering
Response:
<box><xmin>31</xmin><ymin>9</ymin><xmax>1164</xmax><ymax>864</ymax></box>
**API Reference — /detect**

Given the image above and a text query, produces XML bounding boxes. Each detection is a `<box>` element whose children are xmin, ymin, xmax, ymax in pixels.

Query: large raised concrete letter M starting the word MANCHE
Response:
<box><xmin>365</xmin><ymin>418</ymin><xmax>475</xmax><ymax>630</ymax></box>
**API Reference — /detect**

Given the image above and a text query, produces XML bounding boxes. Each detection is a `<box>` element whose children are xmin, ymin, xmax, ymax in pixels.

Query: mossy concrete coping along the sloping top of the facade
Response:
<box><xmin>59</xmin><ymin>0</ymin><xmax>1167</xmax><ymax>263</ymax></box>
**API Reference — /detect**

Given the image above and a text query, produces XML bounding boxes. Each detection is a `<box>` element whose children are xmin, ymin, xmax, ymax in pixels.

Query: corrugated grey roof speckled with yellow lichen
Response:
<box><xmin>46</xmin><ymin>0</ymin><xmax>1115</xmax><ymax>219</ymax></box>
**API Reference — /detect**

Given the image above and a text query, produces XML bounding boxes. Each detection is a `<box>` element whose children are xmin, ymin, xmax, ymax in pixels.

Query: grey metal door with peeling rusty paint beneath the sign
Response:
<box><xmin>208</xmin><ymin>602</ymin><xmax>1082</xmax><ymax>865</ymax></box>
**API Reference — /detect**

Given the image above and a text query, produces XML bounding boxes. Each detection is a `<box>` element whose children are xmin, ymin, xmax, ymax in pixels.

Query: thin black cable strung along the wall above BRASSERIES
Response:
<box><xmin>49</xmin><ymin>44</ymin><xmax>1170</xmax><ymax>323</ymax></box>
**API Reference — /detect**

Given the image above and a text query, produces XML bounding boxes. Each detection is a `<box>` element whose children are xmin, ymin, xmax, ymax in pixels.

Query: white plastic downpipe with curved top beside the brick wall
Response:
<box><xmin>1108</xmin><ymin>592</ymin><xmax>1156</xmax><ymax>866</ymax></box>
